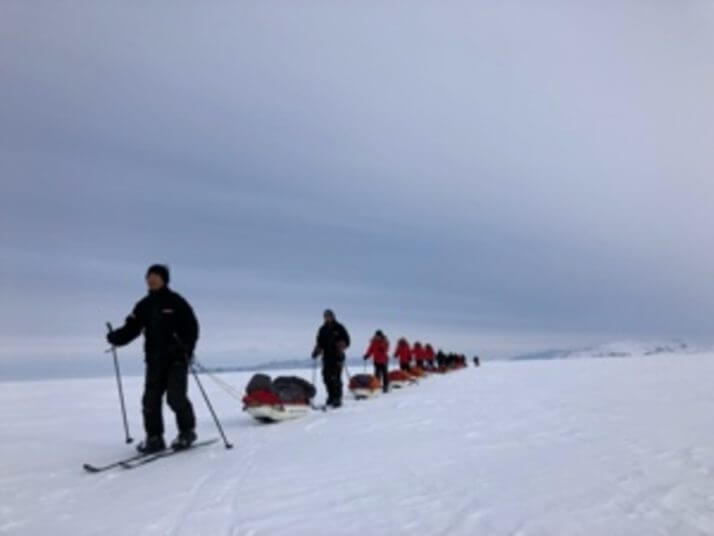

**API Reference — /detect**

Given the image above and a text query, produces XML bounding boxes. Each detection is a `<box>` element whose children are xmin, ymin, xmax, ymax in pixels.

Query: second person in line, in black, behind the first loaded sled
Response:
<box><xmin>312</xmin><ymin>309</ymin><xmax>350</xmax><ymax>408</ymax></box>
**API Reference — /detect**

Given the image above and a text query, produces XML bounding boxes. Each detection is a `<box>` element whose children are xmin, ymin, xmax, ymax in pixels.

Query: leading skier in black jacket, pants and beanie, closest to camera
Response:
<box><xmin>107</xmin><ymin>265</ymin><xmax>198</xmax><ymax>453</ymax></box>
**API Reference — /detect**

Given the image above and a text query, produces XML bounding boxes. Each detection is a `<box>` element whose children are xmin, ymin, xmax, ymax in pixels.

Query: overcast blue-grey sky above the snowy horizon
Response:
<box><xmin>0</xmin><ymin>0</ymin><xmax>714</xmax><ymax>377</ymax></box>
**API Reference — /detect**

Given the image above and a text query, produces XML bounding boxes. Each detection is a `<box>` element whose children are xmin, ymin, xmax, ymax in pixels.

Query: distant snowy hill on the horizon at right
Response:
<box><xmin>511</xmin><ymin>340</ymin><xmax>708</xmax><ymax>361</ymax></box>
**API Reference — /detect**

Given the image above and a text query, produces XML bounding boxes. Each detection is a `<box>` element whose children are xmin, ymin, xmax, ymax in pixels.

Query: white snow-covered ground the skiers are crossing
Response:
<box><xmin>0</xmin><ymin>355</ymin><xmax>714</xmax><ymax>536</ymax></box>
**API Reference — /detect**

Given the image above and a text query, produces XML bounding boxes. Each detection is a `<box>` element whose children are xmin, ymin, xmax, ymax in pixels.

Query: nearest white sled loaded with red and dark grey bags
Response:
<box><xmin>243</xmin><ymin>374</ymin><xmax>316</xmax><ymax>422</ymax></box>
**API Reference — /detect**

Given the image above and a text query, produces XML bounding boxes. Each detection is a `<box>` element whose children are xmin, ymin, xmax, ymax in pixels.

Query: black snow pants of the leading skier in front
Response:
<box><xmin>141</xmin><ymin>360</ymin><xmax>196</xmax><ymax>437</ymax></box>
